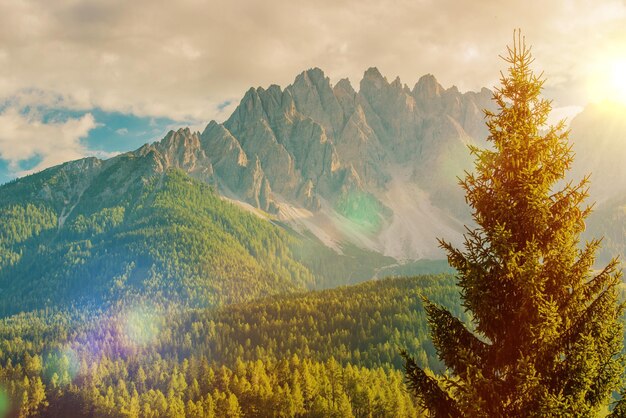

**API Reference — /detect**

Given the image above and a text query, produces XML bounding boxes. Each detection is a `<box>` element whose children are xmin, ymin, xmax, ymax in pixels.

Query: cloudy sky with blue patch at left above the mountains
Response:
<box><xmin>0</xmin><ymin>0</ymin><xmax>626</xmax><ymax>184</ymax></box>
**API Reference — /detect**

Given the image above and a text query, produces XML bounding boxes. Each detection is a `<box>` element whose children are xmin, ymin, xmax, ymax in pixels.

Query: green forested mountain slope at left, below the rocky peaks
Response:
<box><xmin>0</xmin><ymin>168</ymin><xmax>315</xmax><ymax>314</ymax></box>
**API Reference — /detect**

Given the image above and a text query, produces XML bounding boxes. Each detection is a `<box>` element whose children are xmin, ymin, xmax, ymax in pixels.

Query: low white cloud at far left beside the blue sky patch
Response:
<box><xmin>0</xmin><ymin>106</ymin><xmax>97</xmax><ymax>176</ymax></box>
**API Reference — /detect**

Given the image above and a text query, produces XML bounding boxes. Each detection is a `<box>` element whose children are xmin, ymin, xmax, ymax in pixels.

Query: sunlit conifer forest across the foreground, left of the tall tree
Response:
<box><xmin>0</xmin><ymin>276</ymin><xmax>460</xmax><ymax>417</ymax></box>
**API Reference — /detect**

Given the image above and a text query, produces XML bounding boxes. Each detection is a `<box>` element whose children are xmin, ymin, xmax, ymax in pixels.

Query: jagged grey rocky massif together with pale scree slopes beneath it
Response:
<box><xmin>210</xmin><ymin>68</ymin><xmax>492</xmax><ymax>258</ymax></box>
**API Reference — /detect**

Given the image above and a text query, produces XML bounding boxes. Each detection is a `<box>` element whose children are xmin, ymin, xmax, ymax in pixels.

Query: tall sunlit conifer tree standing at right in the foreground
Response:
<box><xmin>403</xmin><ymin>33</ymin><xmax>623</xmax><ymax>417</ymax></box>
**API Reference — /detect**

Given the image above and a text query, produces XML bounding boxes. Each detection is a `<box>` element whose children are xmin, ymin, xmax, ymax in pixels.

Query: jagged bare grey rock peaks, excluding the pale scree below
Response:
<box><xmin>180</xmin><ymin>68</ymin><xmax>491</xmax><ymax>217</ymax></box>
